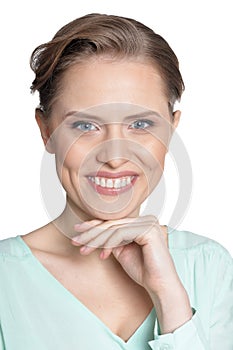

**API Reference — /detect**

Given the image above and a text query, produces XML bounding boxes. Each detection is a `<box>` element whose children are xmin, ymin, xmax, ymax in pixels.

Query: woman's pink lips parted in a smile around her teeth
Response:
<box><xmin>87</xmin><ymin>171</ymin><xmax>138</xmax><ymax>196</ymax></box>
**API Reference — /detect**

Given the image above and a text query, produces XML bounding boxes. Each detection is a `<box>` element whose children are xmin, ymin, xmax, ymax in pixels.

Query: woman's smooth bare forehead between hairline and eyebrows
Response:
<box><xmin>52</xmin><ymin>58</ymin><xmax>168</xmax><ymax>117</ymax></box>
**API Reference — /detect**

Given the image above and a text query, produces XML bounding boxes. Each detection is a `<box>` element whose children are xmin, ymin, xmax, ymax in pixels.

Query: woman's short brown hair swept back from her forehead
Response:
<box><xmin>30</xmin><ymin>14</ymin><xmax>184</xmax><ymax>116</ymax></box>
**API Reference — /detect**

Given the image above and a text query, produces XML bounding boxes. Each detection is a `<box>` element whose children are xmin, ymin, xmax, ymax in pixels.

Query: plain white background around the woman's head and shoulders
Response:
<box><xmin>0</xmin><ymin>0</ymin><xmax>233</xmax><ymax>255</ymax></box>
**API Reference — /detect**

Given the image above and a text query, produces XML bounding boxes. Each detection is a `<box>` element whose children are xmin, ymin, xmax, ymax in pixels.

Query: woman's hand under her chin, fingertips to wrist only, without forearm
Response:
<box><xmin>72</xmin><ymin>215</ymin><xmax>178</xmax><ymax>293</ymax></box>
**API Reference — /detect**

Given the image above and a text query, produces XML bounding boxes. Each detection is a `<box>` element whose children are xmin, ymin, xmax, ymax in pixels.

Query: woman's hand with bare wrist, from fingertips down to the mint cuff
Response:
<box><xmin>72</xmin><ymin>216</ymin><xmax>192</xmax><ymax>334</ymax></box>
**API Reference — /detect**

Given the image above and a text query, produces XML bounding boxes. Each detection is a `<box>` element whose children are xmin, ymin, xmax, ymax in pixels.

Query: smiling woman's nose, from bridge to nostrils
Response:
<box><xmin>97</xmin><ymin>124</ymin><xmax>131</xmax><ymax>169</ymax></box>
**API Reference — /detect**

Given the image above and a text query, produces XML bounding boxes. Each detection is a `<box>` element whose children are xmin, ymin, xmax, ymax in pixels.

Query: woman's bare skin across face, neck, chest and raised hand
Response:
<box><xmin>23</xmin><ymin>57</ymin><xmax>192</xmax><ymax>341</ymax></box>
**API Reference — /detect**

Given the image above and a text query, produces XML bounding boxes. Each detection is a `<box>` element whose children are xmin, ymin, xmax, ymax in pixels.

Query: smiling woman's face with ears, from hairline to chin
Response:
<box><xmin>37</xmin><ymin>58</ymin><xmax>179</xmax><ymax>220</ymax></box>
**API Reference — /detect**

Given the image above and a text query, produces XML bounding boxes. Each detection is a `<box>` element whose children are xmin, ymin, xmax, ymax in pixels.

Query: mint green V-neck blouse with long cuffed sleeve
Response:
<box><xmin>0</xmin><ymin>228</ymin><xmax>233</xmax><ymax>350</ymax></box>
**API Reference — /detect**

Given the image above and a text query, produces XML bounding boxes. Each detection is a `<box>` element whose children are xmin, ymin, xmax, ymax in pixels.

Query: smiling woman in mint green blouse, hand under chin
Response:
<box><xmin>0</xmin><ymin>14</ymin><xmax>233</xmax><ymax>350</ymax></box>
